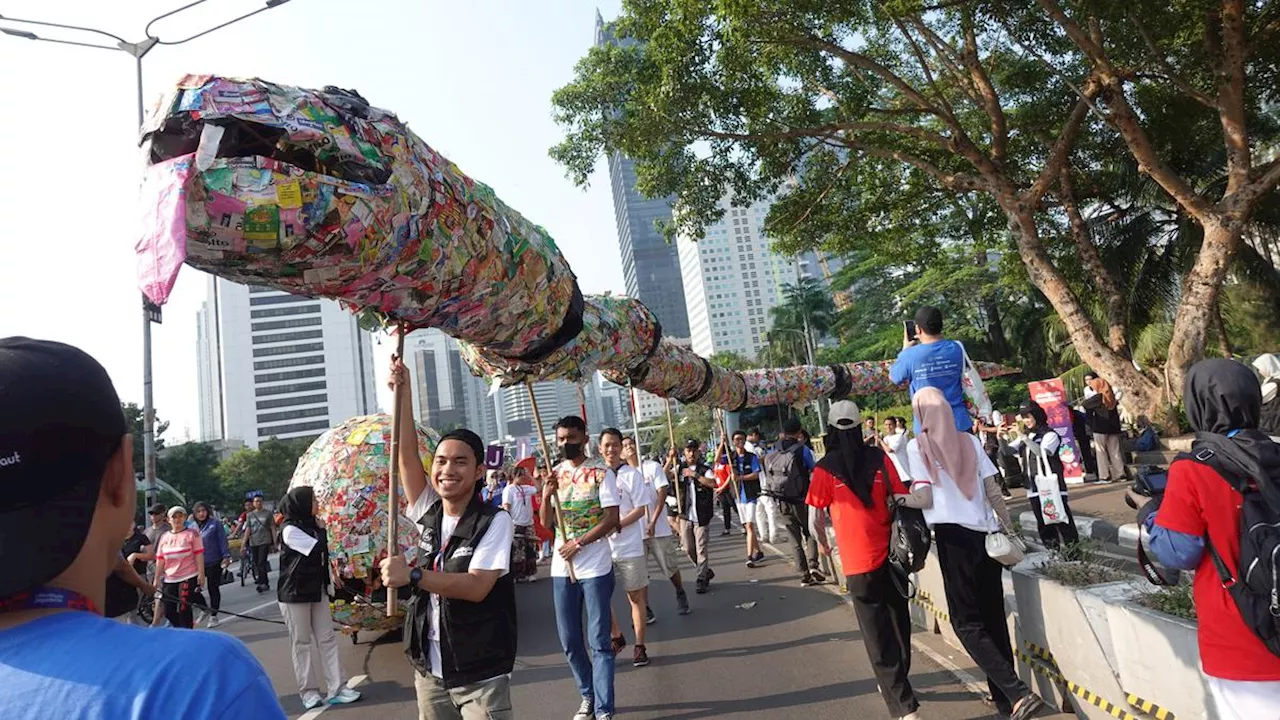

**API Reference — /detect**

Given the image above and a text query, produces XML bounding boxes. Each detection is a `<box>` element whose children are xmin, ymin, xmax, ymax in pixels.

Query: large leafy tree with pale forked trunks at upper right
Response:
<box><xmin>552</xmin><ymin>0</ymin><xmax>1280</xmax><ymax>418</ymax></box>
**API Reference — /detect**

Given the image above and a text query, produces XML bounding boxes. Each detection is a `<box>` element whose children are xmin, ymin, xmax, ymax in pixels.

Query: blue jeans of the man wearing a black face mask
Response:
<box><xmin>552</xmin><ymin>570</ymin><xmax>613</xmax><ymax>716</ymax></box>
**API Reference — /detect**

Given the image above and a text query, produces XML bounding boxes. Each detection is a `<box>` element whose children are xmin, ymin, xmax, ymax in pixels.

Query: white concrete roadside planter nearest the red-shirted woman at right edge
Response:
<box><xmin>1107</xmin><ymin>601</ymin><xmax>1217</xmax><ymax>720</ymax></box>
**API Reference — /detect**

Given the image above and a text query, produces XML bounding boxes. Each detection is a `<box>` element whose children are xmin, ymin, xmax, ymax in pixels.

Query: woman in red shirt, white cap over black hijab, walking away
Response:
<box><xmin>805</xmin><ymin>400</ymin><xmax>921</xmax><ymax>720</ymax></box>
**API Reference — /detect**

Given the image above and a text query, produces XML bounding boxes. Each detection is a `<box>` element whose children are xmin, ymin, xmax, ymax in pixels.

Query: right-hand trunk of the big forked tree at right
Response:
<box><xmin>1165</xmin><ymin>218</ymin><xmax>1240</xmax><ymax>398</ymax></box>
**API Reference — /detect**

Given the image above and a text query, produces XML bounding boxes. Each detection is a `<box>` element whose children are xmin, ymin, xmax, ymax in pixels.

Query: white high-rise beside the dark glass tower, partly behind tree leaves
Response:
<box><xmin>677</xmin><ymin>197</ymin><xmax>838</xmax><ymax>363</ymax></box>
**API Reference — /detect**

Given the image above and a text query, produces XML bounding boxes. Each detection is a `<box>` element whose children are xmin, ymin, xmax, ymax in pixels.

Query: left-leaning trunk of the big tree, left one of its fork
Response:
<box><xmin>1002</xmin><ymin>204</ymin><xmax>1174</xmax><ymax>428</ymax></box>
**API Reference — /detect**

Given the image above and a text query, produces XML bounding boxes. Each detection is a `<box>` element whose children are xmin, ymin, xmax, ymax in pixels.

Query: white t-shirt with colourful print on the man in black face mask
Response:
<box><xmin>552</xmin><ymin>457</ymin><xmax>618</xmax><ymax>580</ymax></box>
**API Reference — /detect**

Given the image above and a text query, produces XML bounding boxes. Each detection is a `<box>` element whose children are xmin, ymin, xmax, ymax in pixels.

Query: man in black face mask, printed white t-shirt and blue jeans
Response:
<box><xmin>539</xmin><ymin>415</ymin><xmax>618</xmax><ymax>720</ymax></box>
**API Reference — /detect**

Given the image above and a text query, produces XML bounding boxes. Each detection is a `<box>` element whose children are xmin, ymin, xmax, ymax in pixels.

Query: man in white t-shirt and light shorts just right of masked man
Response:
<box><xmin>600</xmin><ymin>428</ymin><xmax>653</xmax><ymax>667</ymax></box>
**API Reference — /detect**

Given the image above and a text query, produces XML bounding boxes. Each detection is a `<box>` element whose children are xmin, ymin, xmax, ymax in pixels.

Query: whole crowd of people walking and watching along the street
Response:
<box><xmin>0</xmin><ymin>307</ymin><xmax>1280</xmax><ymax>720</ymax></box>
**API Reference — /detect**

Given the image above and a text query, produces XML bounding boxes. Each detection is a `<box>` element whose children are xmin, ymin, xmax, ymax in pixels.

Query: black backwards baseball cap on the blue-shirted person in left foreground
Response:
<box><xmin>0</xmin><ymin>337</ymin><xmax>129</xmax><ymax>597</ymax></box>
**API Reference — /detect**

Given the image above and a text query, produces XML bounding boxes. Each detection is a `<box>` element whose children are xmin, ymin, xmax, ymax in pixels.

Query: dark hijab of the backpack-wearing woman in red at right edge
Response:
<box><xmin>1183</xmin><ymin>359</ymin><xmax>1280</xmax><ymax>509</ymax></box>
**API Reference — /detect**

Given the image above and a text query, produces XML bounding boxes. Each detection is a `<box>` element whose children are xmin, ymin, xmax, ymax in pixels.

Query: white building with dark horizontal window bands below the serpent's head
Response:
<box><xmin>196</xmin><ymin>277</ymin><xmax>378</xmax><ymax>448</ymax></box>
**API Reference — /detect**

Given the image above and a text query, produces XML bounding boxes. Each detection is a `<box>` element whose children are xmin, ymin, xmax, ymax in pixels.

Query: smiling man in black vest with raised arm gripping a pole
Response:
<box><xmin>381</xmin><ymin>357</ymin><xmax>516</xmax><ymax>720</ymax></box>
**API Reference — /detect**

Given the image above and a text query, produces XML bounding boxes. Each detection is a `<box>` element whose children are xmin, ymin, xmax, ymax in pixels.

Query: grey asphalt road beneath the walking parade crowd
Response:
<box><xmin>212</xmin><ymin>523</ymin><xmax>996</xmax><ymax>720</ymax></box>
